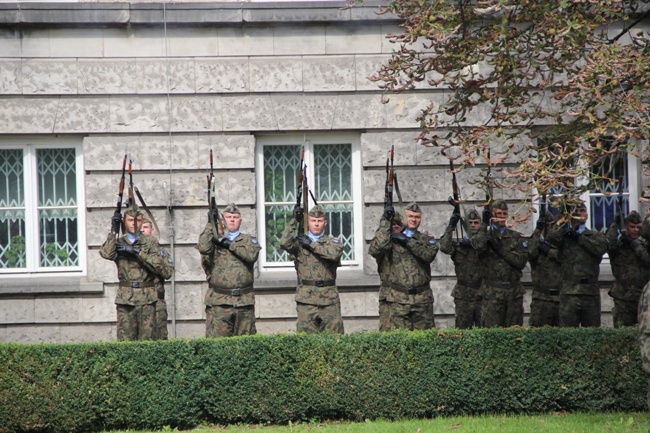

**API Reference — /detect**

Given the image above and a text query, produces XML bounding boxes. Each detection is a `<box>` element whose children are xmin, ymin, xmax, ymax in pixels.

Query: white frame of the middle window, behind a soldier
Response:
<box><xmin>255</xmin><ymin>133</ymin><xmax>364</xmax><ymax>272</ymax></box>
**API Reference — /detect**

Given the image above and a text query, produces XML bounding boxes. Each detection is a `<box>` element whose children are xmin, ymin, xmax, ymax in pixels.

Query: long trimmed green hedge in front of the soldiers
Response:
<box><xmin>0</xmin><ymin>328</ymin><xmax>647</xmax><ymax>432</ymax></box>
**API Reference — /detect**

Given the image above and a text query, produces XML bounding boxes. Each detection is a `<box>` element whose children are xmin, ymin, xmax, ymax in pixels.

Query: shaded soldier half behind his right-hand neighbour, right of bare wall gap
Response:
<box><xmin>440</xmin><ymin>210</ymin><xmax>481</xmax><ymax>329</ymax></box>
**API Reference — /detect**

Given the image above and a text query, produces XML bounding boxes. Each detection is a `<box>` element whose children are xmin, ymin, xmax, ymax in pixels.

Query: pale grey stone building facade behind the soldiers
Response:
<box><xmin>0</xmin><ymin>1</ymin><xmax>640</xmax><ymax>343</ymax></box>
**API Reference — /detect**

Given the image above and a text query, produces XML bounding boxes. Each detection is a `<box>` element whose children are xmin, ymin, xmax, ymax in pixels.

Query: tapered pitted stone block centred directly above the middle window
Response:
<box><xmin>271</xmin><ymin>95</ymin><xmax>338</xmax><ymax>130</ymax></box>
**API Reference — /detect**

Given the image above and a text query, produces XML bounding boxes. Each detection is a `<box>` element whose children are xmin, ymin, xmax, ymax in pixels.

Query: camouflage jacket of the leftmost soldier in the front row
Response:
<box><xmin>99</xmin><ymin>233</ymin><xmax>174</xmax><ymax>305</ymax></box>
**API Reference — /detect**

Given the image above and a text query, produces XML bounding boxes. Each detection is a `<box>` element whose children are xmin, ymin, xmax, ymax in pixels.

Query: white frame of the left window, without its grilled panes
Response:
<box><xmin>0</xmin><ymin>137</ymin><xmax>88</xmax><ymax>279</ymax></box>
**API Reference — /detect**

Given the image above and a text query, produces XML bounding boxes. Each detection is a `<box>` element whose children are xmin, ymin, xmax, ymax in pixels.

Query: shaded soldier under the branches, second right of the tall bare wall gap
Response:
<box><xmin>470</xmin><ymin>200</ymin><xmax>528</xmax><ymax>327</ymax></box>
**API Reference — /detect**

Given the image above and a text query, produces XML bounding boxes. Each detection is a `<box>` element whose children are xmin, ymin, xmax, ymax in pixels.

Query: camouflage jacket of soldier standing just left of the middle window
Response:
<box><xmin>197</xmin><ymin>223</ymin><xmax>262</xmax><ymax>307</ymax></box>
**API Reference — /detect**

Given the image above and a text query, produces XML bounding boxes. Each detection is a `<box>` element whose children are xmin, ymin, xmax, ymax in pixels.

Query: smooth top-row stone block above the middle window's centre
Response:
<box><xmin>273</xmin><ymin>25</ymin><xmax>327</xmax><ymax>56</ymax></box>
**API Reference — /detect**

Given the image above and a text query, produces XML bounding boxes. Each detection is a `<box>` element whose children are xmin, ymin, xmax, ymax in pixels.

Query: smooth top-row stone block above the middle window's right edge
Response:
<box><xmin>325</xmin><ymin>26</ymin><xmax>384</xmax><ymax>54</ymax></box>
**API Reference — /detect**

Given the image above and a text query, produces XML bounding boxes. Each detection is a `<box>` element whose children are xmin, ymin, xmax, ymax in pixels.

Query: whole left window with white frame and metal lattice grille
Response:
<box><xmin>0</xmin><ymin>140</ymin><xmax>86</xmax><ymax>274</ymax></box>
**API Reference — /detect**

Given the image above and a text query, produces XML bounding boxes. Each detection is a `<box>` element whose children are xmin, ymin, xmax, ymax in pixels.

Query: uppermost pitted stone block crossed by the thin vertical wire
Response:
<box><xmin>135</xmin><ymin>58</ymin><xmax>196</xmax><ymax>94</ymax></box>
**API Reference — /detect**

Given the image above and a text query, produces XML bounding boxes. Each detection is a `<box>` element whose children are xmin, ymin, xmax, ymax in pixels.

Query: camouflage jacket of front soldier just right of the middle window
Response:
<box><xmin>369</xmin><ymin>220</ymin><xmax>439</xmax><ymax>304</ymax></box>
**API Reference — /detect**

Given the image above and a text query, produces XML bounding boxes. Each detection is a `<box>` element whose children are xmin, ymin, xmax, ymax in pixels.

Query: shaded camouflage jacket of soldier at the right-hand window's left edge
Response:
<box><xmin>548</xmin><ymin>227</ymin><xmax>607</xmax><ymax>296</ymax></box>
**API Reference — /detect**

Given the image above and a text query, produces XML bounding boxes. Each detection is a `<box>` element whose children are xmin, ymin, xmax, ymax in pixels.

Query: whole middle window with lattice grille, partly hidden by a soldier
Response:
<box><xmin>257</xmin><ymin>134</ymin><xmax>363</xmax><ymax>269</ymax></box>
